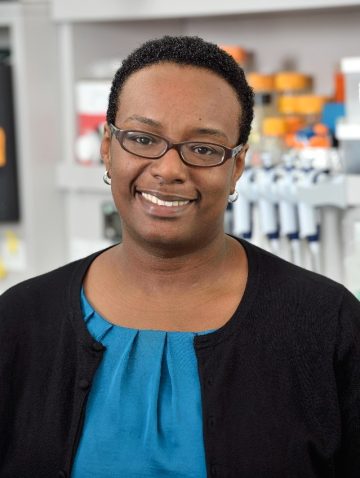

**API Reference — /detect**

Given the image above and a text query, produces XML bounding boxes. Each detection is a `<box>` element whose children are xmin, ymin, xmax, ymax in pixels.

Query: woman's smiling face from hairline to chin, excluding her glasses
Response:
<box><xmin>102</xmin><ymin>63</ymin><xmax>245</xmax><ymax>250</ymax></box>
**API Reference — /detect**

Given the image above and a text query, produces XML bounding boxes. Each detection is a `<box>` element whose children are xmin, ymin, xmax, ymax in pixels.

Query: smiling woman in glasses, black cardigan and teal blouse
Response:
<box><xmin>0</xmin><ymin>37</ymin><xmax>360</xmax><ymax>478</ymax></box>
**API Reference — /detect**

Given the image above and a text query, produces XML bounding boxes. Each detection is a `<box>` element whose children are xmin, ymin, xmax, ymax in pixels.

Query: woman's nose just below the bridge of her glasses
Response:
<box><xmin>151</xmin><ymin>149</ymin><xmax>188</xmax><ymax>183</ymax></box>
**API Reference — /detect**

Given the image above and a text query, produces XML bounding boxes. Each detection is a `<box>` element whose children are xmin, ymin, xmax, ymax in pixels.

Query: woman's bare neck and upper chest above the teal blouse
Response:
<box><xmin>85</xmin><ymin>234</ymin><xmax>247</xmax><ymax>331</ymax></box>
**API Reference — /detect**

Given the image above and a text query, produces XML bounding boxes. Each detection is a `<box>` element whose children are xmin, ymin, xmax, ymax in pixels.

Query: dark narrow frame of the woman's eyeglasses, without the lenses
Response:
<box><xmin>109</xmin><ymin>123</ymin><xmax>244</xmax><ymax>168</ymax></box>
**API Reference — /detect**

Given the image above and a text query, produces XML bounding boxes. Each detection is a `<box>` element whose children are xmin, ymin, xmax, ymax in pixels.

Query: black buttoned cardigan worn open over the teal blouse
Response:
<box><xmin>0</xmin><ymin>242</ymin><xmax>360</xmax><ymax>478</ymax></box>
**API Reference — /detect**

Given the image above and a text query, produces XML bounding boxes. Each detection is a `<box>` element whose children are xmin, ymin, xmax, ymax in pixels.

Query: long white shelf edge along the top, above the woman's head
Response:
<box><xmin>52</xmin><ymin>0</ymin><xmax>360</xmax><ymax>22</ymax></box>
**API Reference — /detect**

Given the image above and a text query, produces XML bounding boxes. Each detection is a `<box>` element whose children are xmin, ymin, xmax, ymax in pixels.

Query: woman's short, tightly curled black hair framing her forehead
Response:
<box><xmin>106</xmin><ymin>36</ymin><xmax>254</xmax><ymax>144</ymax></box>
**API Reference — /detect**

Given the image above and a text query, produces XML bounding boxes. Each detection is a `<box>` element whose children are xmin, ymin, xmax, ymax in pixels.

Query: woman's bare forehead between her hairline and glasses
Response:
<box><xmin>117</xmin><ymin>63</ymin><xmax>241</xmax><ymax>136</ymax></box>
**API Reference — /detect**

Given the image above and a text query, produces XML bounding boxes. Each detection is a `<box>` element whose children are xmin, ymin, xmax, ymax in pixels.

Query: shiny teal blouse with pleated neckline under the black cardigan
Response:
<box><xmin>71</xmin><ymin>290</ymin><xmax>215</xmax><ymax>478</ymax></box>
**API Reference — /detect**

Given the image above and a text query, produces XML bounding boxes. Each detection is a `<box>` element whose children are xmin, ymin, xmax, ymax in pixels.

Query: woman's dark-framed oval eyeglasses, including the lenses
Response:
<box><xmin>110</xmin><ymin>123</ymin><xmax>243</xmax><ymax>168</ymax></box>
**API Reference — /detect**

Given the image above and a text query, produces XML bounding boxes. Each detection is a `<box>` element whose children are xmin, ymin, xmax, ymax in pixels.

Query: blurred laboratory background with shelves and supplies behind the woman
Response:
<box><xmin>0</xmin><ymin>0</ymin><xmax>360</xmax><ymax>299</ymax></box>
